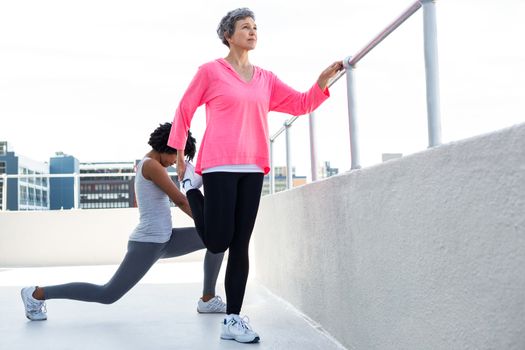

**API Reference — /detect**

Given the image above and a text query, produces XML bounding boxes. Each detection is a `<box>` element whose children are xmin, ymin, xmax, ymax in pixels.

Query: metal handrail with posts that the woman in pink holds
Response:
<box><xmin>270</xmin><ymin>0</ymin><xmax>441</xmax><ymax>193</ymax></box>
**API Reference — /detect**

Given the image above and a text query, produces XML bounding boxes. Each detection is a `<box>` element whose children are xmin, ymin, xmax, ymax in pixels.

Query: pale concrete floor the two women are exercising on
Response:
<box><xmin>0</xmin><ymin>262</ymin><xmax>344</xmax><ymax>350</ymax></box>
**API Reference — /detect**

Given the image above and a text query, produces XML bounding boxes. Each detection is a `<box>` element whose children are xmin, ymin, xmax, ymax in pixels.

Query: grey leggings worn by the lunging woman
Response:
<box><xmin>43</xmin><ymin>227</ymin><xmax>224</xmax><ymax>304</ymax></box>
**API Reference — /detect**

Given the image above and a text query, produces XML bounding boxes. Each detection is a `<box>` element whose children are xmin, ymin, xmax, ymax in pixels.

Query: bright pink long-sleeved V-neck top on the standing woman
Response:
<box><xmin>168</xmin><ymin>58</ymin><xmax>330</xmax><ymax>174</ymax></box>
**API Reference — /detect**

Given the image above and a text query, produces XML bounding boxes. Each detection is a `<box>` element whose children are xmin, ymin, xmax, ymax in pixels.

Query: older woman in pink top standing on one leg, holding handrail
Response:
<box><xmin>168</xmin><ymin>8</ymin><xmax>342</xmax><ymax>343</ymax></box>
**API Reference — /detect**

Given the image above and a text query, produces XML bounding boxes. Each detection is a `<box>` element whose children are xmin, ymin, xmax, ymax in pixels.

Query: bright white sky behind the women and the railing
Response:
<box><xmin>0</xmin><ymin>0</ymin><xmax>525</xmax><ymax>175</ymax></box>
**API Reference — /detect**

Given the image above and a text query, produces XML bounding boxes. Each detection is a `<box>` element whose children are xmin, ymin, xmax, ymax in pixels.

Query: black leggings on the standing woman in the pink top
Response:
<box><xmin>186</xmin><ymin>172</ymin><xmax>264</xmax><ymax>314</ymax></box>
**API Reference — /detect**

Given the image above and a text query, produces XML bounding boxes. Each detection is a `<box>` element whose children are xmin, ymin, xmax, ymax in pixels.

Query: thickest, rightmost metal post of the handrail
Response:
<box><xmin>421</xmin><ymin>0</ymin><xmax>441</xmax><ymax>147</ymax></box>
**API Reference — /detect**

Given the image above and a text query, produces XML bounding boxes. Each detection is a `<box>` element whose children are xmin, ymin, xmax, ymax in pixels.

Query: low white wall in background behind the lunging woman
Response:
<box><xmin>0</xmin><ymin>208</ymin><xmax>204</xmax><ymax>267</ymax></box>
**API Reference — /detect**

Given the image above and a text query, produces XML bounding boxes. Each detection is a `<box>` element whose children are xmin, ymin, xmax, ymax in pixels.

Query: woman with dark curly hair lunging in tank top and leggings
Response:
<box><xmin>21</xmin><ymin>123</ymin><xmax>226</xmax><ymax>321</ymax></box>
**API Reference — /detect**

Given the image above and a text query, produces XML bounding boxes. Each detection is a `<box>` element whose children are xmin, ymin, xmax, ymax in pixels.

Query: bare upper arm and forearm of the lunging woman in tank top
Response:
<box><xmin>142</xmin><ymin>159</ymin><xmax>193</xmax><ymax>218</ymax></box>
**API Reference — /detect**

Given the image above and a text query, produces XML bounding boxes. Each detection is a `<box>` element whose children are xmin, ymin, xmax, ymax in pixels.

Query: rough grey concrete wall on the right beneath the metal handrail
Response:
<box><xmin>254</xmin><ymin>124</ymin><xmax>525</xmax><ymax>350</ymax></box>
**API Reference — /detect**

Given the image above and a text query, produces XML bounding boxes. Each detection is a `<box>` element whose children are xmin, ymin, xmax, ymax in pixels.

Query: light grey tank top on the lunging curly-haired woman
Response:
<box><xmin>129</xmin><ymin>157</ymin><xmax>171</xmax><ymax>243</ymax></box>
